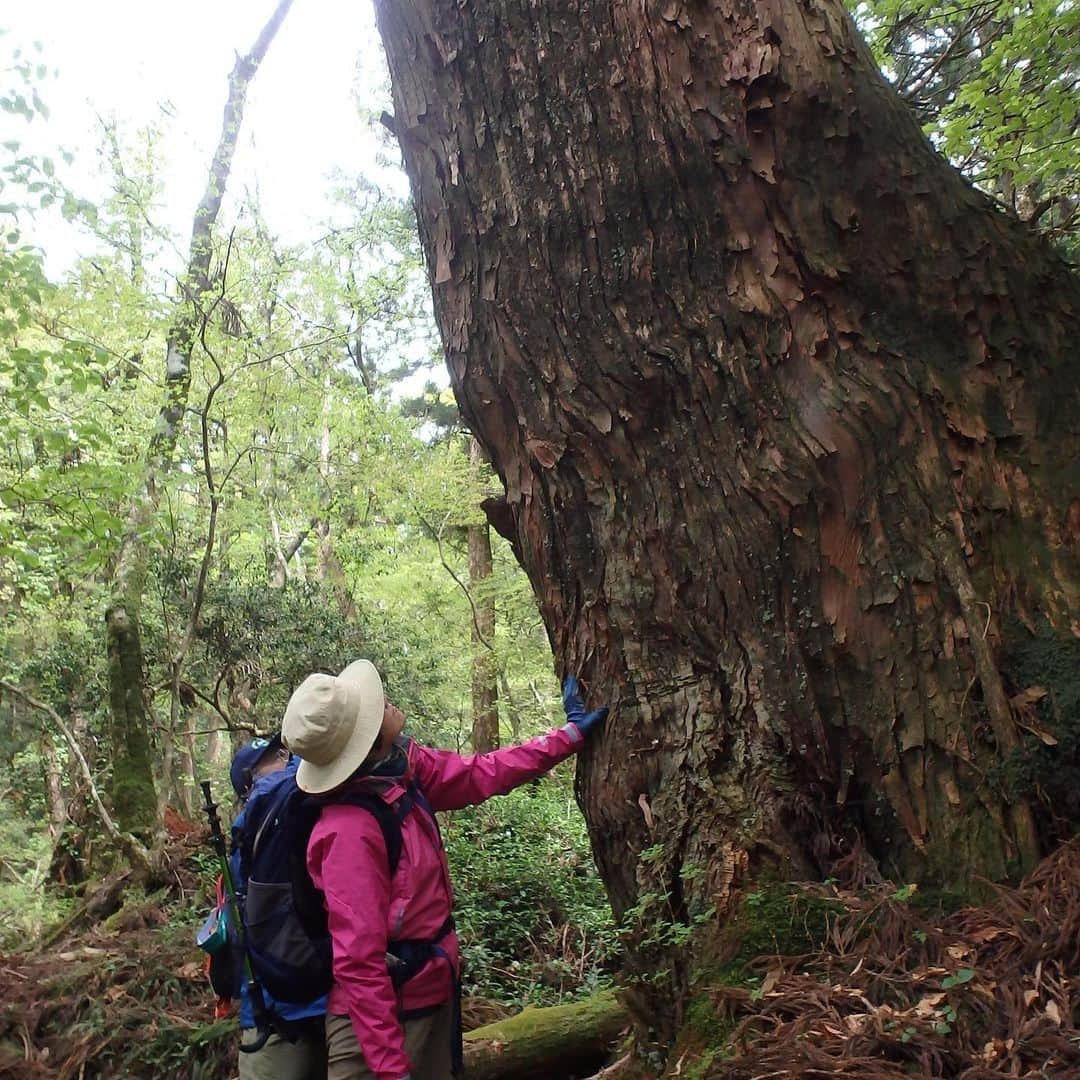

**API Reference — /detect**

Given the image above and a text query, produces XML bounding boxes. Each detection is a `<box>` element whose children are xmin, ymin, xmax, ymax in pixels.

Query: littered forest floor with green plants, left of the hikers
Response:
<box><xmin>0</xmin><ymin>823</ymin><xmax>511</xmax><ymax>1080</ymax></box>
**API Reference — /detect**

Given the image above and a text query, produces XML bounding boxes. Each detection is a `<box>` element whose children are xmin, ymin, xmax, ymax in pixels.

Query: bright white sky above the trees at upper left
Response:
<box><xmin>0</xmin><ymin>0</ymin><xmax>407</xmax><ymax>273</ymax></box>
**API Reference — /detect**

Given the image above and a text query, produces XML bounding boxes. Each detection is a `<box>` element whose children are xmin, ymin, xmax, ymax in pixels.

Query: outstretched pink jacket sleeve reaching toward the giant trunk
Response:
<box><xmin>409</xmin><ymin>724</ymin><xmax>583</xmax><ymax>810</ymax></box>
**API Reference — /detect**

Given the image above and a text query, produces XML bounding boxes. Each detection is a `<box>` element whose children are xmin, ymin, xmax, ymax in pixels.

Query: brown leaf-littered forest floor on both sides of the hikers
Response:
<box><xmin>0</xmin><ymin>835</ymin><xmax>1080</xmax><ymax>1080</ymax></box>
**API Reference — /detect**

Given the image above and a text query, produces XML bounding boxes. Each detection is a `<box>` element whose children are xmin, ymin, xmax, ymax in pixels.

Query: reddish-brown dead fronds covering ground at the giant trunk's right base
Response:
<box><xmin>666</xmin><ymin>837</ymin><xmax>1080</xmax><ymax>1080</ymax></box>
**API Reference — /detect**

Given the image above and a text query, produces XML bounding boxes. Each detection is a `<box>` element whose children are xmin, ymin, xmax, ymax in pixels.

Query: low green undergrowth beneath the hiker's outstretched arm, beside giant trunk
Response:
<box><xmin>443</xmin><ymin>770</ymin><xmax>617</xmax><ymax>1005</ymax></box>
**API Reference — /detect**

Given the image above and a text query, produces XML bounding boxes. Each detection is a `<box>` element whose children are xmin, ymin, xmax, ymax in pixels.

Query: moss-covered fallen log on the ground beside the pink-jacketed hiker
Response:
<box><xmin>464</xmin><ymin>990</ymin><xmax>630</xmax><ymax>1080</ymax></box>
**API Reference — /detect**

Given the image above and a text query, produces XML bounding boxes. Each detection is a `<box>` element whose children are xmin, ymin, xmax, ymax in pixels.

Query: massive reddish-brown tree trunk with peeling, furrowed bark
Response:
<box><xmin>378</xmin><ymin>0</ymin><xmax>1080</xmax><ymax>1054</ymax></box>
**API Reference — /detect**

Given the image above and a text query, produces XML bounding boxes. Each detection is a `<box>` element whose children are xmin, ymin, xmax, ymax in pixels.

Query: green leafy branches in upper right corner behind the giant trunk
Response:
<box><xmin>852</xmin><ymin>0</ymin><xmax>1080</xmax><ymax>254</ymax></box>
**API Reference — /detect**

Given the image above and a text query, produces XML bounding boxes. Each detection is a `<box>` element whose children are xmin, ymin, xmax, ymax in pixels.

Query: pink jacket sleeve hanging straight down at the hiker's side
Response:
<box><xmin>308</xmin><ymin>806</ymin><xmax>409</xmax><ymax>1080</ymax></box>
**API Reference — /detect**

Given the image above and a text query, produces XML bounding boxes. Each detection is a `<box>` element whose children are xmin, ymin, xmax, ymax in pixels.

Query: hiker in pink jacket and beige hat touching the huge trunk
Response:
<box><xmin>282</xmin><ymin>660</ymin><xmax>607</xmax><ymax>1080</ymax></box>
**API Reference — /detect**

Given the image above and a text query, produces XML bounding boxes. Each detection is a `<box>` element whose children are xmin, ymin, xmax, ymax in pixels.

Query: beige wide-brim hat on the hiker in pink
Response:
<box><xmin>281</xmin><ymin>660</ymin><xmax>383</xmax><ymax>795</ymax></box>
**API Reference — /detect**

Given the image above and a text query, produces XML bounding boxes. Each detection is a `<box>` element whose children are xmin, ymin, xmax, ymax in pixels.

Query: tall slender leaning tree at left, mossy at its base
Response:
<box><xmin>105</xmin><ymin>0</ymin><xmax>293</xmax><ymax>837</ymax></box>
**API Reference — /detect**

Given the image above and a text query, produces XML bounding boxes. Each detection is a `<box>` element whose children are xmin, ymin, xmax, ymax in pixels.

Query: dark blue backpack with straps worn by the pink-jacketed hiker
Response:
<box><xmin>238</xmin><ymin>777</ymin><xmax>434</xmax><ymax>1003</ymax></box>
